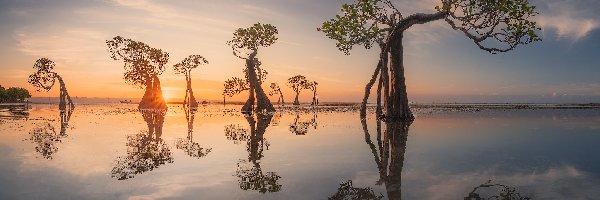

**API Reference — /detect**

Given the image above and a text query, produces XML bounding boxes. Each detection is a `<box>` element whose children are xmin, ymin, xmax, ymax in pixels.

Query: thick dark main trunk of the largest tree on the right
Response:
<box><xmin>387</xmin><ymin>32</ymin><xmax>414</xmax><ymax>122</ymax></box>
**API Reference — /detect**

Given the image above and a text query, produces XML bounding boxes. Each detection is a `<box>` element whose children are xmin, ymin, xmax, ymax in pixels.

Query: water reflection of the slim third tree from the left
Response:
<box><xmin>176</xmin><ymin>105</ymin><xmax>212</xmax><ymax>158</ymax></box>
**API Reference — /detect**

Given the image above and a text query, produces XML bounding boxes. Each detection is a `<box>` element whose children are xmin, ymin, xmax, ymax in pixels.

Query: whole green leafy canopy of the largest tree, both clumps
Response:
<box><xmin>317</xmin><ymin>0</ymin><xmax>541</xmax><ymax>55</ymax></box>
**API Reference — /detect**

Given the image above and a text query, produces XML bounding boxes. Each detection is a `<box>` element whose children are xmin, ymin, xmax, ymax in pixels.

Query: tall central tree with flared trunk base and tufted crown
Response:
<box><xmin>227</xmin><ymin>23</ymin><xmax>278</xmax><ymax>113</ymax></box>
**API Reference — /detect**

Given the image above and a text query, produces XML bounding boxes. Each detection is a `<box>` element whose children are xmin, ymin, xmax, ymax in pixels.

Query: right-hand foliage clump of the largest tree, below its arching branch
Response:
<box><xmin>436</xmin><ymin>0</ymin><xmax>541</xmax><ymax>53</ymax></box>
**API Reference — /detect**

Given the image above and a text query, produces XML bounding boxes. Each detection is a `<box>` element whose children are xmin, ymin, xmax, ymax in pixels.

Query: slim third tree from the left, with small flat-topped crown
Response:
<box><xmin>173</xmin><ymin>55</ymin><xmax>208</xmax><ymax>108</ymax></box>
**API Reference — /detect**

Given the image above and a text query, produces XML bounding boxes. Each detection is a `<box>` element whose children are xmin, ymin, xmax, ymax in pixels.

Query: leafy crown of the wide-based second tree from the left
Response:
<box><xmin>106</xmin><ymin>36</ymin><xmax>169</xmax><ymax>88</ymax></box>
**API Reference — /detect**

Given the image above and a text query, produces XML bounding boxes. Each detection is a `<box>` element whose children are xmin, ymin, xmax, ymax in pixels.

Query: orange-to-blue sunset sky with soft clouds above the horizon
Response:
<box><xmin>0</xmin><ymin>0</ymin><xmax>600</xmax><ymax>103</ymax></box>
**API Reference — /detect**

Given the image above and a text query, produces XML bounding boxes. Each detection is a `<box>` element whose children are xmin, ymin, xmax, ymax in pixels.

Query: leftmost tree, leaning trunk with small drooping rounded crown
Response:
<box><xmin>27</xmin><ymin>58</ymin><xmax>75</xmax><ymax>111</ymax></box>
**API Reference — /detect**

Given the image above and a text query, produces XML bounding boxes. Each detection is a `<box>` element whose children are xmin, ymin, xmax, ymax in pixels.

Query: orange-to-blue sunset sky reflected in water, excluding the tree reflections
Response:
<box><xmin>0</xmin><ymin>105</ymin><xmax>600</xmax><ymax>199</ymax></box>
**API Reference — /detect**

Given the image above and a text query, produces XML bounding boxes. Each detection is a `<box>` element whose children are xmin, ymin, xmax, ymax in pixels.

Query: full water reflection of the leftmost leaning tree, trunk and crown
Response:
<box><xmin>29</xmin><ymin>109</ymin><xmax>73</xmax><ymax>159</ymax></box>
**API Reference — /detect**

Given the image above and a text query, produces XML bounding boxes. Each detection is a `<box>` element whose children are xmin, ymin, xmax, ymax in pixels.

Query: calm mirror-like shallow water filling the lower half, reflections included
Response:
<box><xmin>0</xmin><ymin>104</ymin><xmax>600</xmax><ymax>199</ymax></box>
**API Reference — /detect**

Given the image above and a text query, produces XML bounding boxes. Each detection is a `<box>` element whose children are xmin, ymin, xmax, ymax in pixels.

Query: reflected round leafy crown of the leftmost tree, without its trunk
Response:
<box><xmin>29</xmin><ymin>123</ymin><xmax>61</xmax><ymax>159</ymax></box>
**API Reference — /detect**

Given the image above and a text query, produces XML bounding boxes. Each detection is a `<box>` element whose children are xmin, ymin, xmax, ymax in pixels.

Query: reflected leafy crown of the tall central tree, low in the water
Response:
<box><xmin>235</xmin><ymin>160</ymin><xmax>281</xmax><ymax>193</ymax></box>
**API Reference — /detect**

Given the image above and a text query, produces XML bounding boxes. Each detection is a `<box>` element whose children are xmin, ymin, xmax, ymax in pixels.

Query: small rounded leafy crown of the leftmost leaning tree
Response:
<box><xmin>27</xmin><ymin>58</ymin><xmax>57</xmax><ymax>92</ymax></box>
